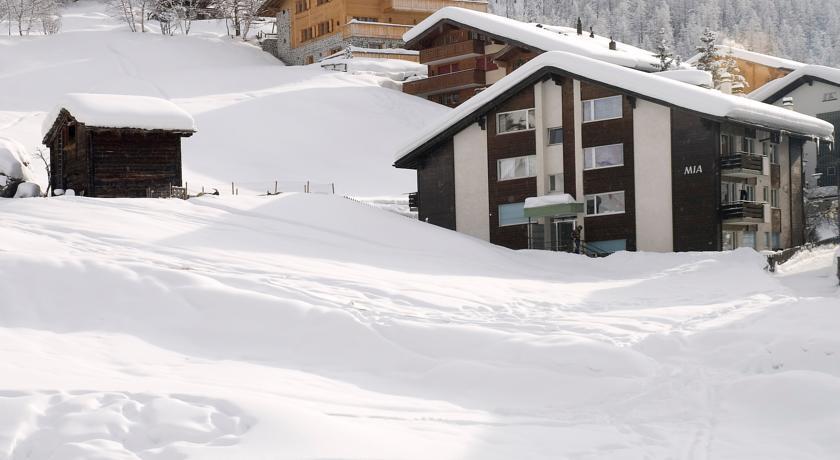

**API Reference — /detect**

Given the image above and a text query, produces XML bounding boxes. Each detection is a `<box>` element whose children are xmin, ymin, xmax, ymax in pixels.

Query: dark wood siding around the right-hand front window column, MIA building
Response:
<box><xmin>571</xmin><ymin>83</ymin><xmax>636</xmax><ymax>251</ymax></box>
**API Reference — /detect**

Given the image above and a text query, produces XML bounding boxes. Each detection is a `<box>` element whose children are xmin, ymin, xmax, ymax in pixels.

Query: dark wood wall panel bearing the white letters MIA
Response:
<box><xmin>671</xmin><ymin>108</ymin><xmax>721</xmax><ymax>251</ymax></box>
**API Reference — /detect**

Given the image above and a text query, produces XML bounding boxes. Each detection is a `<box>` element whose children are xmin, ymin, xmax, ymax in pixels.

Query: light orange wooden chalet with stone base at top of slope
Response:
<box><xmin>259</xmin><ymin>0</ymin><xmax>487</xmax><ymax>65</ymax></box>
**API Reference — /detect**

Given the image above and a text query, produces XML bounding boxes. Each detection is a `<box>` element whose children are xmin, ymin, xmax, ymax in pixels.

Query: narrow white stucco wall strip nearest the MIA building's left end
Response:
<box><xmin>454</xmin><ymin>123</ymin><xmax>490</xmax><ymax>241</ymax></box>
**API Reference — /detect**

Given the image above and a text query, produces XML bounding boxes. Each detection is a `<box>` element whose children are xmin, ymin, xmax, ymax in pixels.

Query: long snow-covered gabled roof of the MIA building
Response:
<box><xmin>396</xmin><ymin>52</ymin><xmax>834</xmax><ymax>165</ymax></box>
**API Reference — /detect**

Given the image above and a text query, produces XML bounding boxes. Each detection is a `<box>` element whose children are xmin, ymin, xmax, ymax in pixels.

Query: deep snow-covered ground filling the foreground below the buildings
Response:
<box><xmin>0</xmin><ymin>194</ymin><xmax>840</xmax><ymax>460</ymax></box>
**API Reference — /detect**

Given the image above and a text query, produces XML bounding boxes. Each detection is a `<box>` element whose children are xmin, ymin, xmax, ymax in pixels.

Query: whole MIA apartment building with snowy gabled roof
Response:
<box><xmin>395</xmin><ymin>52</ymin><xmax>834</xmax><ymax>253</ymax></box>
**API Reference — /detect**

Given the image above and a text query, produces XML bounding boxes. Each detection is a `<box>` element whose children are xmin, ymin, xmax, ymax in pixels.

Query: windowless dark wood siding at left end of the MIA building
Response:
<box><xmin>417</xmin><ymin>138</ymin><xmax>455</xmax><ymax>230</ymax></box>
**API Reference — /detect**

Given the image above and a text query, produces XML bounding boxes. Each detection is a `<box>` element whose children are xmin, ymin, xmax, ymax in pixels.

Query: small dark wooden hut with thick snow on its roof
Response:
<box><xmin>43</xmin><ymin>94</ymin><xmax>195</xmax><ymax>198</ymax></box>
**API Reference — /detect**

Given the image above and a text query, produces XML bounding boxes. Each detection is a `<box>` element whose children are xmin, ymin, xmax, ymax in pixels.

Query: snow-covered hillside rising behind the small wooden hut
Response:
<box><xmin>0</xmin><ymin>1</ymin><xmax>448</xmax><ymax>195</ymax></box>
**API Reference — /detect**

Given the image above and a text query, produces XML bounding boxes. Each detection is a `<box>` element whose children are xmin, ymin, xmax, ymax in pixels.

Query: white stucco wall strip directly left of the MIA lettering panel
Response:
<box><xmin>633</xmin><ymin>99</ymin><xmax>674</xmax><ymax>252</ymax></box>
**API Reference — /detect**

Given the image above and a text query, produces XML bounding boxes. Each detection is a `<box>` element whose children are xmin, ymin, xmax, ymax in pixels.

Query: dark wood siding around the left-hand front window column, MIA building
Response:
<box><xmin>487</xmin><ymin>82</ymin><xmax>537</xmax><ymax>249</ymax></box>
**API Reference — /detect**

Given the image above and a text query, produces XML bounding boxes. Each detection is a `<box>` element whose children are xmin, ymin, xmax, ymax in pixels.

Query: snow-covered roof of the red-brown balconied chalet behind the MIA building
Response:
<box><xmin>403</xmin><ymin>6</ymin><xmax>660</xmax><ymax>71</ymax></box>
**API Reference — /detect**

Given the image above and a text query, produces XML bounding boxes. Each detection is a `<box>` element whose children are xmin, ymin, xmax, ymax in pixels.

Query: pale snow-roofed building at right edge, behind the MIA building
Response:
<box><xmin>748</xmin><ymin>65</ymin><xmax>840</xmax><ymax>188</ymax></box>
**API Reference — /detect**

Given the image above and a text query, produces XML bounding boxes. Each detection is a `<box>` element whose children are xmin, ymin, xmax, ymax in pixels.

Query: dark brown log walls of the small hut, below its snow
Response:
<box><xmin>45</xmin><ymin>111</ymin><xmax>192</xmax><ymax>198</ymax></box>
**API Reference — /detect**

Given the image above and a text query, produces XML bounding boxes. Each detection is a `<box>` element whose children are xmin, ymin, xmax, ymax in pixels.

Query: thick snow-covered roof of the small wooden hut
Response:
<box><xmin>41</xmin><ymin>93</ymin><xmax>195</xmax><ymax>137</ymax></box>
